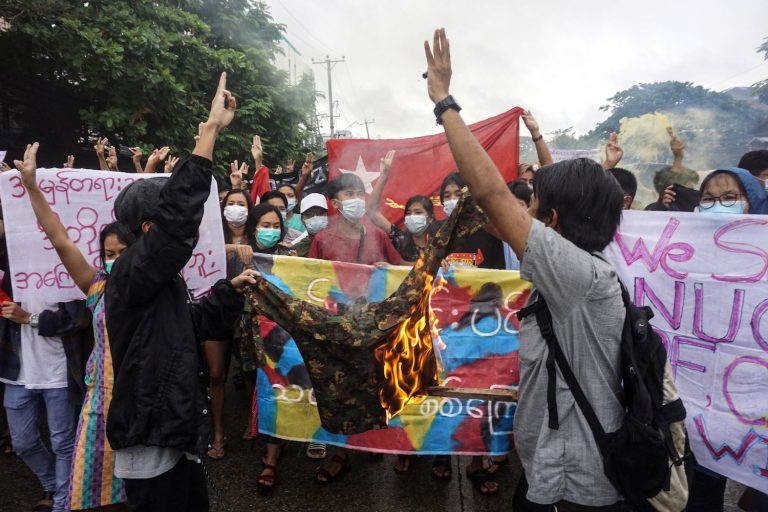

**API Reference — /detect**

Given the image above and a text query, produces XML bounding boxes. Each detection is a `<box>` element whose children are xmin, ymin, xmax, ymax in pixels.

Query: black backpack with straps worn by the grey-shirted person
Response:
<box><xmin>517</xmin><ymin>281</ymin><xmax>693</xmax><ymax>512</ymax></box>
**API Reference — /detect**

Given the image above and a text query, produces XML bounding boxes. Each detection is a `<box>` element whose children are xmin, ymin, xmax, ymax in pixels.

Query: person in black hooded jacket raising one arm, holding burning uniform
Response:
<box><xmin>106</xmin><ymin>73</ymin><xmax>255</xmax><ymax>511</ymax></box>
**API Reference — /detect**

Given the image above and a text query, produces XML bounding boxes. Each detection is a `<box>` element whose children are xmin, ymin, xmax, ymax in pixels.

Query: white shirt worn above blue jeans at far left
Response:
<box><xmin>0</xmin><ymin>301</ymin><xmax>67</xmax><ymax>389</ymax></box>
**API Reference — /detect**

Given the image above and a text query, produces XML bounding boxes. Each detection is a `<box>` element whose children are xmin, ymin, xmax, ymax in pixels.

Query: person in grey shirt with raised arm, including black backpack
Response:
<box><xmin>425</xmin><ymin>29</ymin><xmax>687</xmax><ymax>512</ymax></box>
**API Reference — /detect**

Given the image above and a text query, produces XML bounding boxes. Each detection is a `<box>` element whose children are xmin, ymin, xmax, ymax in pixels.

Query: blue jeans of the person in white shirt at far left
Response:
<box><xmin>4</xmin><ymin>384</ymin><xmax>77</xmax><ymax>512</ymax></box>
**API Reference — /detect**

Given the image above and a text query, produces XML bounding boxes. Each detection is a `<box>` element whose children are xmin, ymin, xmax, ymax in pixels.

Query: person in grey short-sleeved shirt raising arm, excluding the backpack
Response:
<box><xmin>424</xmin><ymin>29</ymin><xmax>625</xmax><ymax>512</ymax></box>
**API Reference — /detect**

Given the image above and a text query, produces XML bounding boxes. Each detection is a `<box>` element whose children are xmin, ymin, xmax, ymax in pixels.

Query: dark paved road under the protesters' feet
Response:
<box><xmin>0</xmin><ymin>388</ymin><xmax>741</xmax><ymax>512</ymax></box>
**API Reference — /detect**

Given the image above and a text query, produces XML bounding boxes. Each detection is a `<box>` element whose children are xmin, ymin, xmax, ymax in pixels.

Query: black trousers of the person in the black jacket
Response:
<box><xmin>123</xmin><ymin>457</ymin><xmax>209</xmax><ymax>512</ymax></box>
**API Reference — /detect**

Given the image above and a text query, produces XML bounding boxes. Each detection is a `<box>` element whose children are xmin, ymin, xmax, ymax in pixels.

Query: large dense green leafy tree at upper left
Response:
<box><xmin>0</xmin><ymin>0</ymin><xmax>316</xmax><ymax>173</ymax></box>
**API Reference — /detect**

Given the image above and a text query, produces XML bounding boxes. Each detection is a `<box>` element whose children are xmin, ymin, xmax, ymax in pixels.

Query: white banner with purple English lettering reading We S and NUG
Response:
<box><xmin>606</xmin><ymin>211</ymin><xmax>768</xmax><ymax>492</ymax></box>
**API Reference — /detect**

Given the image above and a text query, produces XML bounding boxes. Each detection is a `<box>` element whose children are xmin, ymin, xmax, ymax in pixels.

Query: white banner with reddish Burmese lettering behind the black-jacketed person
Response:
<box><xmin>0</xmin><ymin>169</ymin><xmax>226</xmax><ymax>302</ymax></box>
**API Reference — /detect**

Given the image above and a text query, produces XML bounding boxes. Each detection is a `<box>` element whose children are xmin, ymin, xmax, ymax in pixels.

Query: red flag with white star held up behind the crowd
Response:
<box><xmin>326</xmin><ymin>107</ymin><xmax>523</xmax><ymax>224</ymax></box>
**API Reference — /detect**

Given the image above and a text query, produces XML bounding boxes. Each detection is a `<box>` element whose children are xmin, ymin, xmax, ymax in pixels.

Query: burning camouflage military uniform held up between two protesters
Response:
<box><xmin>243</xmin><ymin>194</ymin><xmax>487</xmax><ymax>435</ymax></box>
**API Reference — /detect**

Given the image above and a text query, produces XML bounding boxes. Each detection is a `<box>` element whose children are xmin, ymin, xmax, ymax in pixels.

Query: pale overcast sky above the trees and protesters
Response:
<box><xmin>267</xmin><ymin>0</ymin><xmax>768</xmax><ymax>138</ymax></box>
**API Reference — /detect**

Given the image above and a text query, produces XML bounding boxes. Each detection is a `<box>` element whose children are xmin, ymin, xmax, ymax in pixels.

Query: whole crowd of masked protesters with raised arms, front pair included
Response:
<box><xmin>0</xmin><ymin>30</ymin><xmax>768</xmax><ymax>511</ymax></box>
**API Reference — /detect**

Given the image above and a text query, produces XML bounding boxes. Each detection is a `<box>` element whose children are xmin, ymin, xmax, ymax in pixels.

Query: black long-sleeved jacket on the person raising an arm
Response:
<box><xmin>105</xmin><ymin>156</ymin><xmax>243</xmax><ymax>453</ymax></box>
